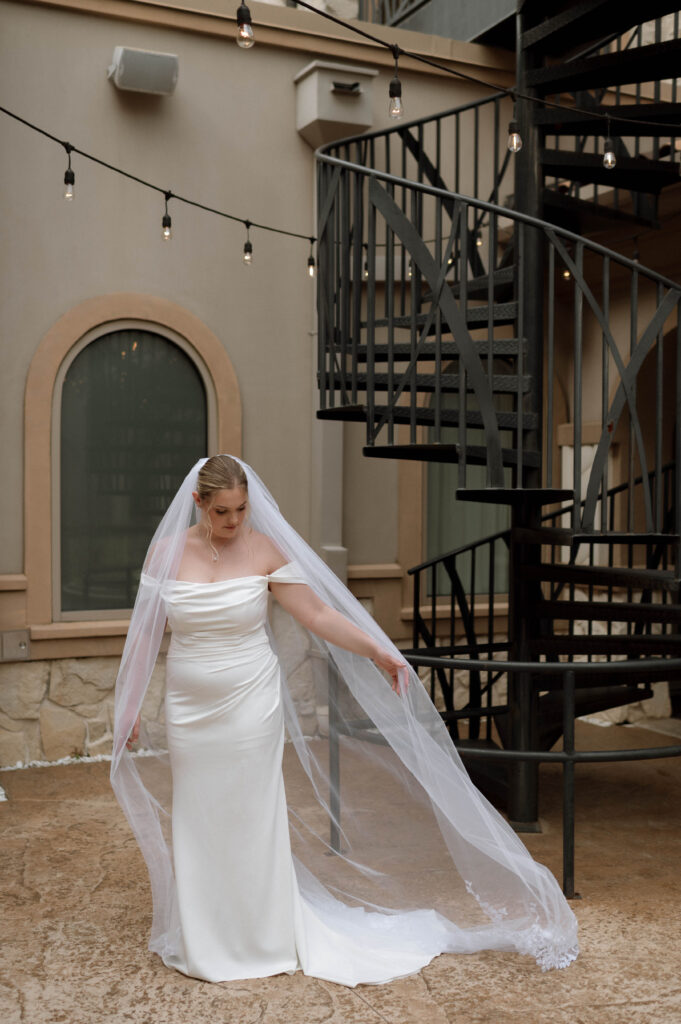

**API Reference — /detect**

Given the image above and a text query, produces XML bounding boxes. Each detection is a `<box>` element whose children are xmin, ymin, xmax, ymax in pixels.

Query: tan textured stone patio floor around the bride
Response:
<box><xmin>0</xmin><ymin>724</ymin><xmax>681</xmax><ymax>1024</ymax></box>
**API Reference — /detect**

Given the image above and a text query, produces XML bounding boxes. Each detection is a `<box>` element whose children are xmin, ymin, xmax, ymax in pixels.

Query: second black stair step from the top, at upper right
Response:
<box><xmin>526</xmin><ymin>37</ymin><xmax>681</xmax><ymax>95</ymax></box>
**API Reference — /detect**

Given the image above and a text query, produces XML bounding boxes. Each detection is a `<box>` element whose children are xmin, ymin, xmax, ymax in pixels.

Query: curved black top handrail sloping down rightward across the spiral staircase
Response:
<box><xmin>316</xmin><ymin>150</ymin><xmax>681</xmax><ymax>293</ymax></box>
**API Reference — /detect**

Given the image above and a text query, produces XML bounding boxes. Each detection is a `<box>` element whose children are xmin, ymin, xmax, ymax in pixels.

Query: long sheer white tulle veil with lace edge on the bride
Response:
<box><xmin>112</xmin><ymin>460</ymin><xmax>578</xmax><ymax>969</ymax></box>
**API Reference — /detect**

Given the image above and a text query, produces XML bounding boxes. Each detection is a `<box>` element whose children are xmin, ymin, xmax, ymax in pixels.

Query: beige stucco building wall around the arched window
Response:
<box><xmin>0</xmin><ymin>0</ymin><xmax>512</xmax><ymax>658</ymax></box>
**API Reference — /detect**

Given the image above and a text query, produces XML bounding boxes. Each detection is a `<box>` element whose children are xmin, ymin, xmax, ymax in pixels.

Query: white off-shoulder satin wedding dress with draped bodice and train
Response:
<box><xmin>158</xmin><ymin>563</ymin><xmax>458</xmax><ymax>985</ymax></box>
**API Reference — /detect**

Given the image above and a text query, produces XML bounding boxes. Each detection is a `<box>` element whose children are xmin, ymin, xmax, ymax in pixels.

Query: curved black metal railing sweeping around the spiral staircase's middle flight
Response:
<box><xmin>317</xmin><ymin>147</ymin><xmax>681</xmax><ymax>520</ymax></box>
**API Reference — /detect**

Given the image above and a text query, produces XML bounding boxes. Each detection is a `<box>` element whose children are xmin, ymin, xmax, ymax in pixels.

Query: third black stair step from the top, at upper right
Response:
<box><xmin>533</xmin><ymin>103</ymin><xmax>681</xmax><ymax>138</ymax></box>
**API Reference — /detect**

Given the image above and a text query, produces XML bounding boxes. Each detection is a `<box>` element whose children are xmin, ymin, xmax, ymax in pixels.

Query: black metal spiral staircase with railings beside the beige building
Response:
<box><xmin>317</xmin><ymin>0</ymin><xmax>681</xmax><ymax>828</ymax></box>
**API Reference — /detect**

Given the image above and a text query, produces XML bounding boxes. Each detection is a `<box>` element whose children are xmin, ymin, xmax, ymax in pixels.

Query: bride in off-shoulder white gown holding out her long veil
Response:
<box><xmin>112</xmin><ymin>456</ymin><xmax>578</xmax><ymax>985</ymax></box>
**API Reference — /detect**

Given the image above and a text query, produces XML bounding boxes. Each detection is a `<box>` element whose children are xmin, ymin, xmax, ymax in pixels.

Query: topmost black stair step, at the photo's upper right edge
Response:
<box><xmin>521</xmin><ymin>0</ymin><xmax>678</xmax><ymax>56</ymax></box>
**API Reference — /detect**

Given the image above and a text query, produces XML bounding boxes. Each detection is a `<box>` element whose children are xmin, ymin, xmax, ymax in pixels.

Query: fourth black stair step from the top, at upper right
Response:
<box><xmin>540</xmin><ymin>149</ymin><xmax>681</xmax><ymax>194</ymax></box>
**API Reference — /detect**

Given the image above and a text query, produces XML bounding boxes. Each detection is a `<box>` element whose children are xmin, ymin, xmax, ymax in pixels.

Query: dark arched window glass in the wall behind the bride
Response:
<box><xmin>58</xmin><ymin>326</ymin><xmax>208</xmax><ymax>617</ymax></box>
